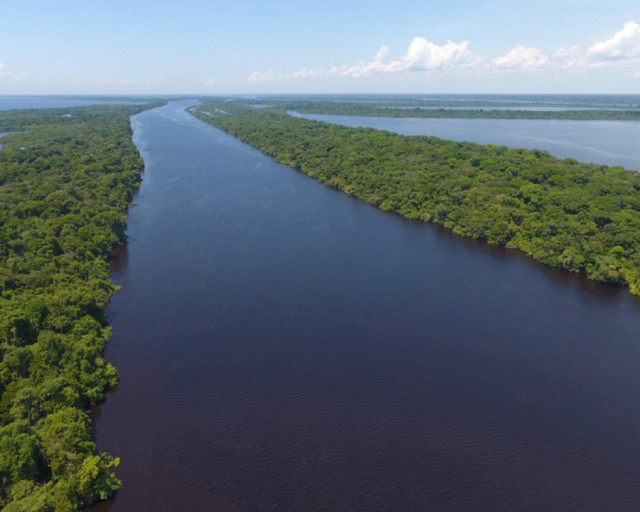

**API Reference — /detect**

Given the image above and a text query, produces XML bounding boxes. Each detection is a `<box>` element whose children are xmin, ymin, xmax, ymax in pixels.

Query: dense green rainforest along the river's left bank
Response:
<box><xmin>0</xmin><ymin>105</ymin><xmax>158</xmax><ymax>512</ymax></box>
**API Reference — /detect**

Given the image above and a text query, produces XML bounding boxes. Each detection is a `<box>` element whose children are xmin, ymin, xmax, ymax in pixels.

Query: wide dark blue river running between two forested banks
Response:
<box><xmin>96</xmin><ymin>102</ymin><xmax>640</xmax><ymax>512</ymax></box>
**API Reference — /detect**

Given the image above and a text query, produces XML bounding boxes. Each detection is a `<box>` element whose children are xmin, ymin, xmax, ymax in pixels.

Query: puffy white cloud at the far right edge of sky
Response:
<box><xmin>587</xmin><ymin>21</ymin><xmax>640</xmax><ymax>67</ymax></box>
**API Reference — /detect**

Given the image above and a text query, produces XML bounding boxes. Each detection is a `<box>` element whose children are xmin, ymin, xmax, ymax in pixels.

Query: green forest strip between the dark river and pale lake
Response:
<box><xmin>193</xmin><ymin>101</ymin><xmax>640</xmax><ymax>295</ymax></box>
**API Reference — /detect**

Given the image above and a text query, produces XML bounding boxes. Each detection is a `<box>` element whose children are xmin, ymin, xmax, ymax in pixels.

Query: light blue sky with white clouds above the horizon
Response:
<box><xmin>0</xmin><ymin>0</ymin><xmax>640</xmax><ymax>94</ymax></box>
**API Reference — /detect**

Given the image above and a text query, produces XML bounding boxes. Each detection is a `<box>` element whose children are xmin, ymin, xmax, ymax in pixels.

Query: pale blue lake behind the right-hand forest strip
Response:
<box><xmin>290</xmin><ymin>112</ymin><xmax>640</xmax><ymax>171</ymax></box>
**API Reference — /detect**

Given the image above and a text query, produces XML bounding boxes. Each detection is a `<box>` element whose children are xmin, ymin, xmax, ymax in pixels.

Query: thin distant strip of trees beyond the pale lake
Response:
<box><xmin>283</xmin><ymin>101</ymin><xmax>640</xmax><ymax>121</ymax></box>
